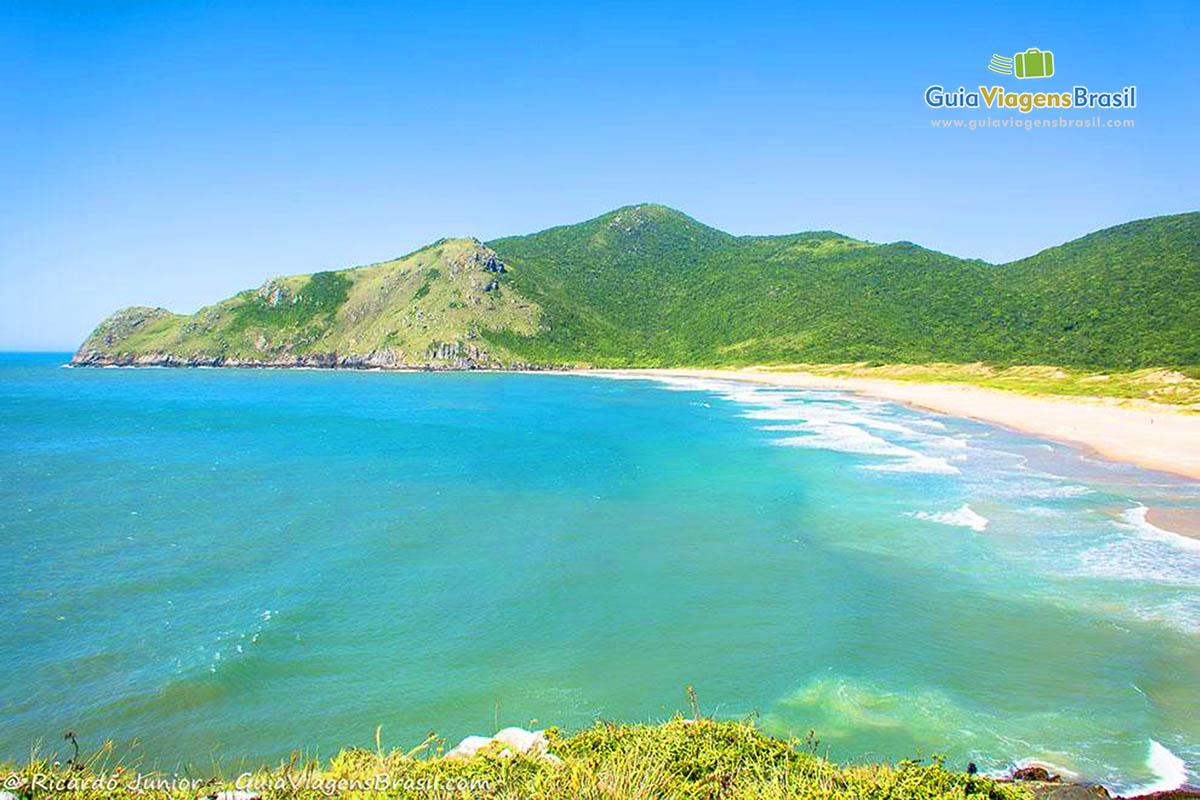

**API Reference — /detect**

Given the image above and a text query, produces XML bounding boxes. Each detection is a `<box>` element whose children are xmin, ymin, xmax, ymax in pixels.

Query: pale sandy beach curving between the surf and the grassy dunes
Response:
<box><xmin>596</xmin><ymin>368</ymin><xmax>1200</xmax><ymax>484</ymax></box>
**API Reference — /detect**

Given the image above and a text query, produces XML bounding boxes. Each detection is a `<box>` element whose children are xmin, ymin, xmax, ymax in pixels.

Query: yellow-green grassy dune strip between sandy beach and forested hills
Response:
<box><xmin>762</xmin><ymin>362</ymin><xmax>1200</xmax><ymax>411</ymax></box>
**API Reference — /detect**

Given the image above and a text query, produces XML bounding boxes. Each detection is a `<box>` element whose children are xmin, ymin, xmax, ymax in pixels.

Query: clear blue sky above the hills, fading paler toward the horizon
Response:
<box><xmin>0</xmin><ymin>0</ymin><xmax>1200</xmax><ymax>349</ymax></box>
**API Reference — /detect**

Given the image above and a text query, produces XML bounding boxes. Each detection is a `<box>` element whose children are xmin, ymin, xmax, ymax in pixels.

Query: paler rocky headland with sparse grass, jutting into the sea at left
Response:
<box><xmin>73</xmin><ymin>239</ymin><xmax>541</xmax><ymax>368</ymax></box>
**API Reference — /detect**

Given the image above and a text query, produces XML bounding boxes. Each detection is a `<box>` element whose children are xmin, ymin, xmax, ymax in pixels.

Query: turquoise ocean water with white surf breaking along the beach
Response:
<box><xmin>0</xmin><ymin>355</ymin><xmax>1200</xmax><ymax>790</ymax></box>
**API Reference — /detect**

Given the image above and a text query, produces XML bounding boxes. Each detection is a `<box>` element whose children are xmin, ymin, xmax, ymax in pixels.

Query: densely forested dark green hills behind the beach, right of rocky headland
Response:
<box><xmin>488</xmin><ymin>205</ymin><xmax>1200</xmax><ymax>369</ymax></box>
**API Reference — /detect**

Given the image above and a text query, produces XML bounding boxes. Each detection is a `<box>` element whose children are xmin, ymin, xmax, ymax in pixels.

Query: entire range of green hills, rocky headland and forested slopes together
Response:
<box><xmin>76</xmin><ymin>205</ymin><xmax>1200</xmax><ymax>369</ymax></box>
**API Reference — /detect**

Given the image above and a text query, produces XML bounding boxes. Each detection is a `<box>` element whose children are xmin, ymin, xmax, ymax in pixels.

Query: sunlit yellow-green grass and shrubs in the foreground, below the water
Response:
<box><xmin>5</xmin><ymin>717</ymin><xmax>1031</xmax><ymax>800</ymax></box>
